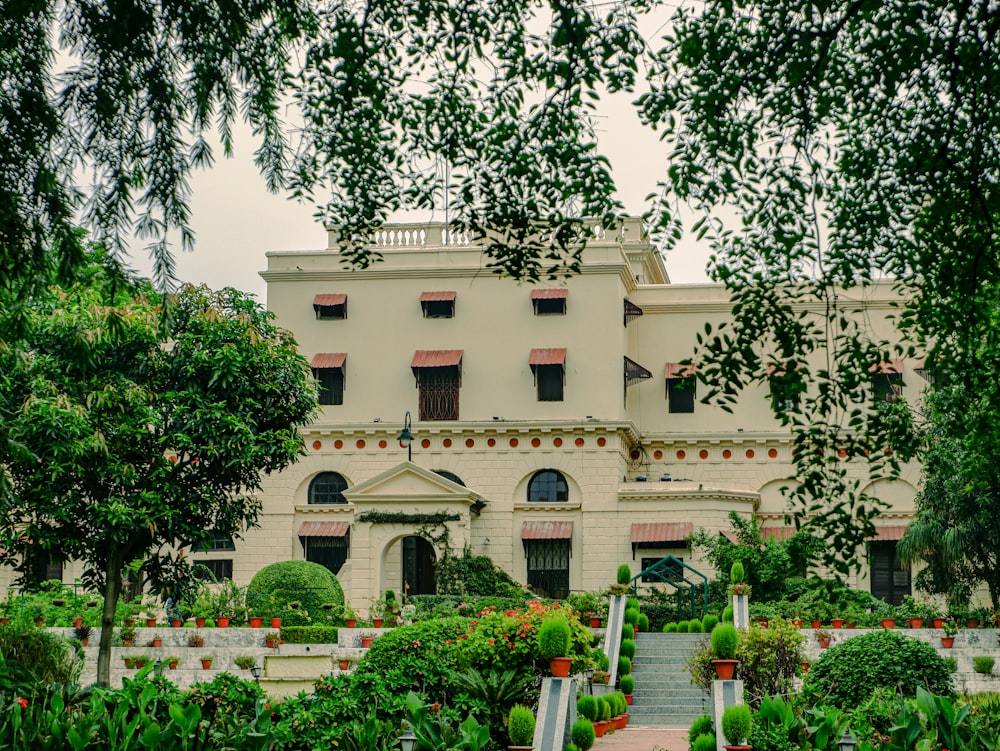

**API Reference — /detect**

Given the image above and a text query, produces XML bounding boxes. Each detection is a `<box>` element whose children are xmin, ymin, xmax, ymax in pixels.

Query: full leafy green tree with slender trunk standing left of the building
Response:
<box><xmin>0</xmin><ymin>262</ymin><xmax>316</xmax><ymax>685</ymax></box>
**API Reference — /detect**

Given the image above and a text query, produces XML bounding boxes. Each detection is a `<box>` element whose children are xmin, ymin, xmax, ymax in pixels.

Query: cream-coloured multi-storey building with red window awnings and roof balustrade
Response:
<box><xmin>7</xmin><ymin>220</ymin><xmax>921</xmax><ymax>608</ymax></box>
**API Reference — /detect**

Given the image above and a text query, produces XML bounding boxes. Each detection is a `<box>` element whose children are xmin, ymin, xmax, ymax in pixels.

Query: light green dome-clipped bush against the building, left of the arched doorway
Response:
<box><xmin>247</xmin><ymin>561</ymin><xmax>344</xmax><ymax>626</ymax></box>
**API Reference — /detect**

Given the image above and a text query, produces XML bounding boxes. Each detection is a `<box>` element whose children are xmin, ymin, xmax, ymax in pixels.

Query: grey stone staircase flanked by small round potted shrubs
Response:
<box><xmin>629</xmin><ymin>633</ymin><xmax>710</xmax><ymax>727</ymax></box>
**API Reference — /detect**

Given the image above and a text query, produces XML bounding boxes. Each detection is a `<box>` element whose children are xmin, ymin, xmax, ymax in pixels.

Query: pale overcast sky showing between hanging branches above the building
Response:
<box><xmin>131</xmin><ymin>95</ymin><xmax>708</xmax><ymax>301</ymax></box>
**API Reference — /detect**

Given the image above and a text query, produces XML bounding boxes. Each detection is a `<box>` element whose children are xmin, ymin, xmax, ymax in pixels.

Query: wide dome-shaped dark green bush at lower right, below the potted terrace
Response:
<box><xmin>802</xmin><ymin>629</ymin><xmax>954</xmax><ymax>707</ymax></box>
